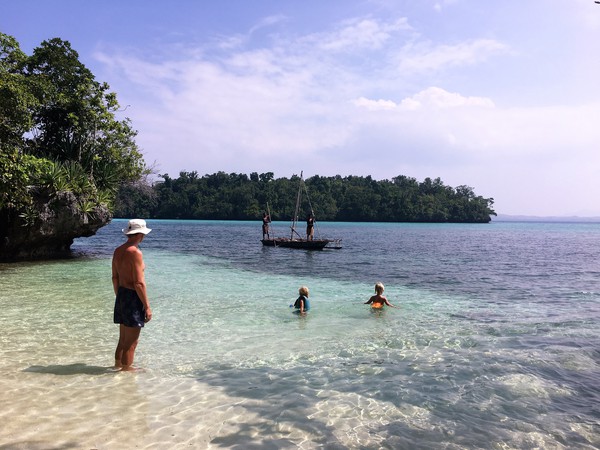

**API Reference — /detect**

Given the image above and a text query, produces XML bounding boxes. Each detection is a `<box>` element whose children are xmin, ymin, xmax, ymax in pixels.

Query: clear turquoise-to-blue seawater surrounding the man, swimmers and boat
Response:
<box><xmin>0</xmin><ymin>220</ymin><xmax>600</xmax><ymax>449</ymax></box>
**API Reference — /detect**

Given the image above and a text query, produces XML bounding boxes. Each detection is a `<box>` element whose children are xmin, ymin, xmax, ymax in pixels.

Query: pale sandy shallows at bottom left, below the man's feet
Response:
<box><xmin>0</xmin><ymin>365</ymin><xmax>221</xmax><ymax>449</ymax></box>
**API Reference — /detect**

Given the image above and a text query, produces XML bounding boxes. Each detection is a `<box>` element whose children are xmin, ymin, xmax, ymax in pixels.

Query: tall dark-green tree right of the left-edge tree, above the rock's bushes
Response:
<box><xmin>26</xmin><ymin>38</ymin><xmax>147</xmax><ymax>189</ymax></box>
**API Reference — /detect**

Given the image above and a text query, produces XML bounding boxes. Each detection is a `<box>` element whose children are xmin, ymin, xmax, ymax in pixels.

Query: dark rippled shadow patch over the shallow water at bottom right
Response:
<box><xmin>196</xmin><ymin>349</ymin><xmax>597</xmax><ymax>449</ymax></box>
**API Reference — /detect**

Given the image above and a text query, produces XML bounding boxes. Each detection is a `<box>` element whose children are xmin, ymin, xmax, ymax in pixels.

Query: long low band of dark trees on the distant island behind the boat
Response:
<box><xmin>114</xmin><ymin>171</ymin><xmax>496</xmax><ymax>223</ymax></box>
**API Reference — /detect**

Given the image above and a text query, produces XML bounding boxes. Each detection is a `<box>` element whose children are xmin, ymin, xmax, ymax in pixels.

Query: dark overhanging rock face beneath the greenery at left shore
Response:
<box><xmin>0</xmin><ymin>191</ymin><xmax>112</xmax><ymax>261</ymax></box>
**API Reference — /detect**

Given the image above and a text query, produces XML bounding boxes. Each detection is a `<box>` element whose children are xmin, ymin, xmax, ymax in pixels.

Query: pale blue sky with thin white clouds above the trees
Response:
<box><xmin>0</xmin><ymin>0</ymin><xmax>600</xmax><ymax>217</ymax></box>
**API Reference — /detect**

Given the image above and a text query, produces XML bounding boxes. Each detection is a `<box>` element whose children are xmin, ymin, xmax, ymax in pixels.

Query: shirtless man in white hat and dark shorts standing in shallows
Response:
<box><xmin>112</xmin><ymin>219</ymin><xmax>152</xmax><ymax>370</ymax></box>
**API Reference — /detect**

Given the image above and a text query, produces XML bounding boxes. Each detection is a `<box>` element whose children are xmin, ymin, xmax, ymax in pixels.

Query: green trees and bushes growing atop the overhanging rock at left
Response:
<box><xmin>0</xmin><ymin>33</ymin><xmax>149</xmax><ymax>225</ymax></box>
